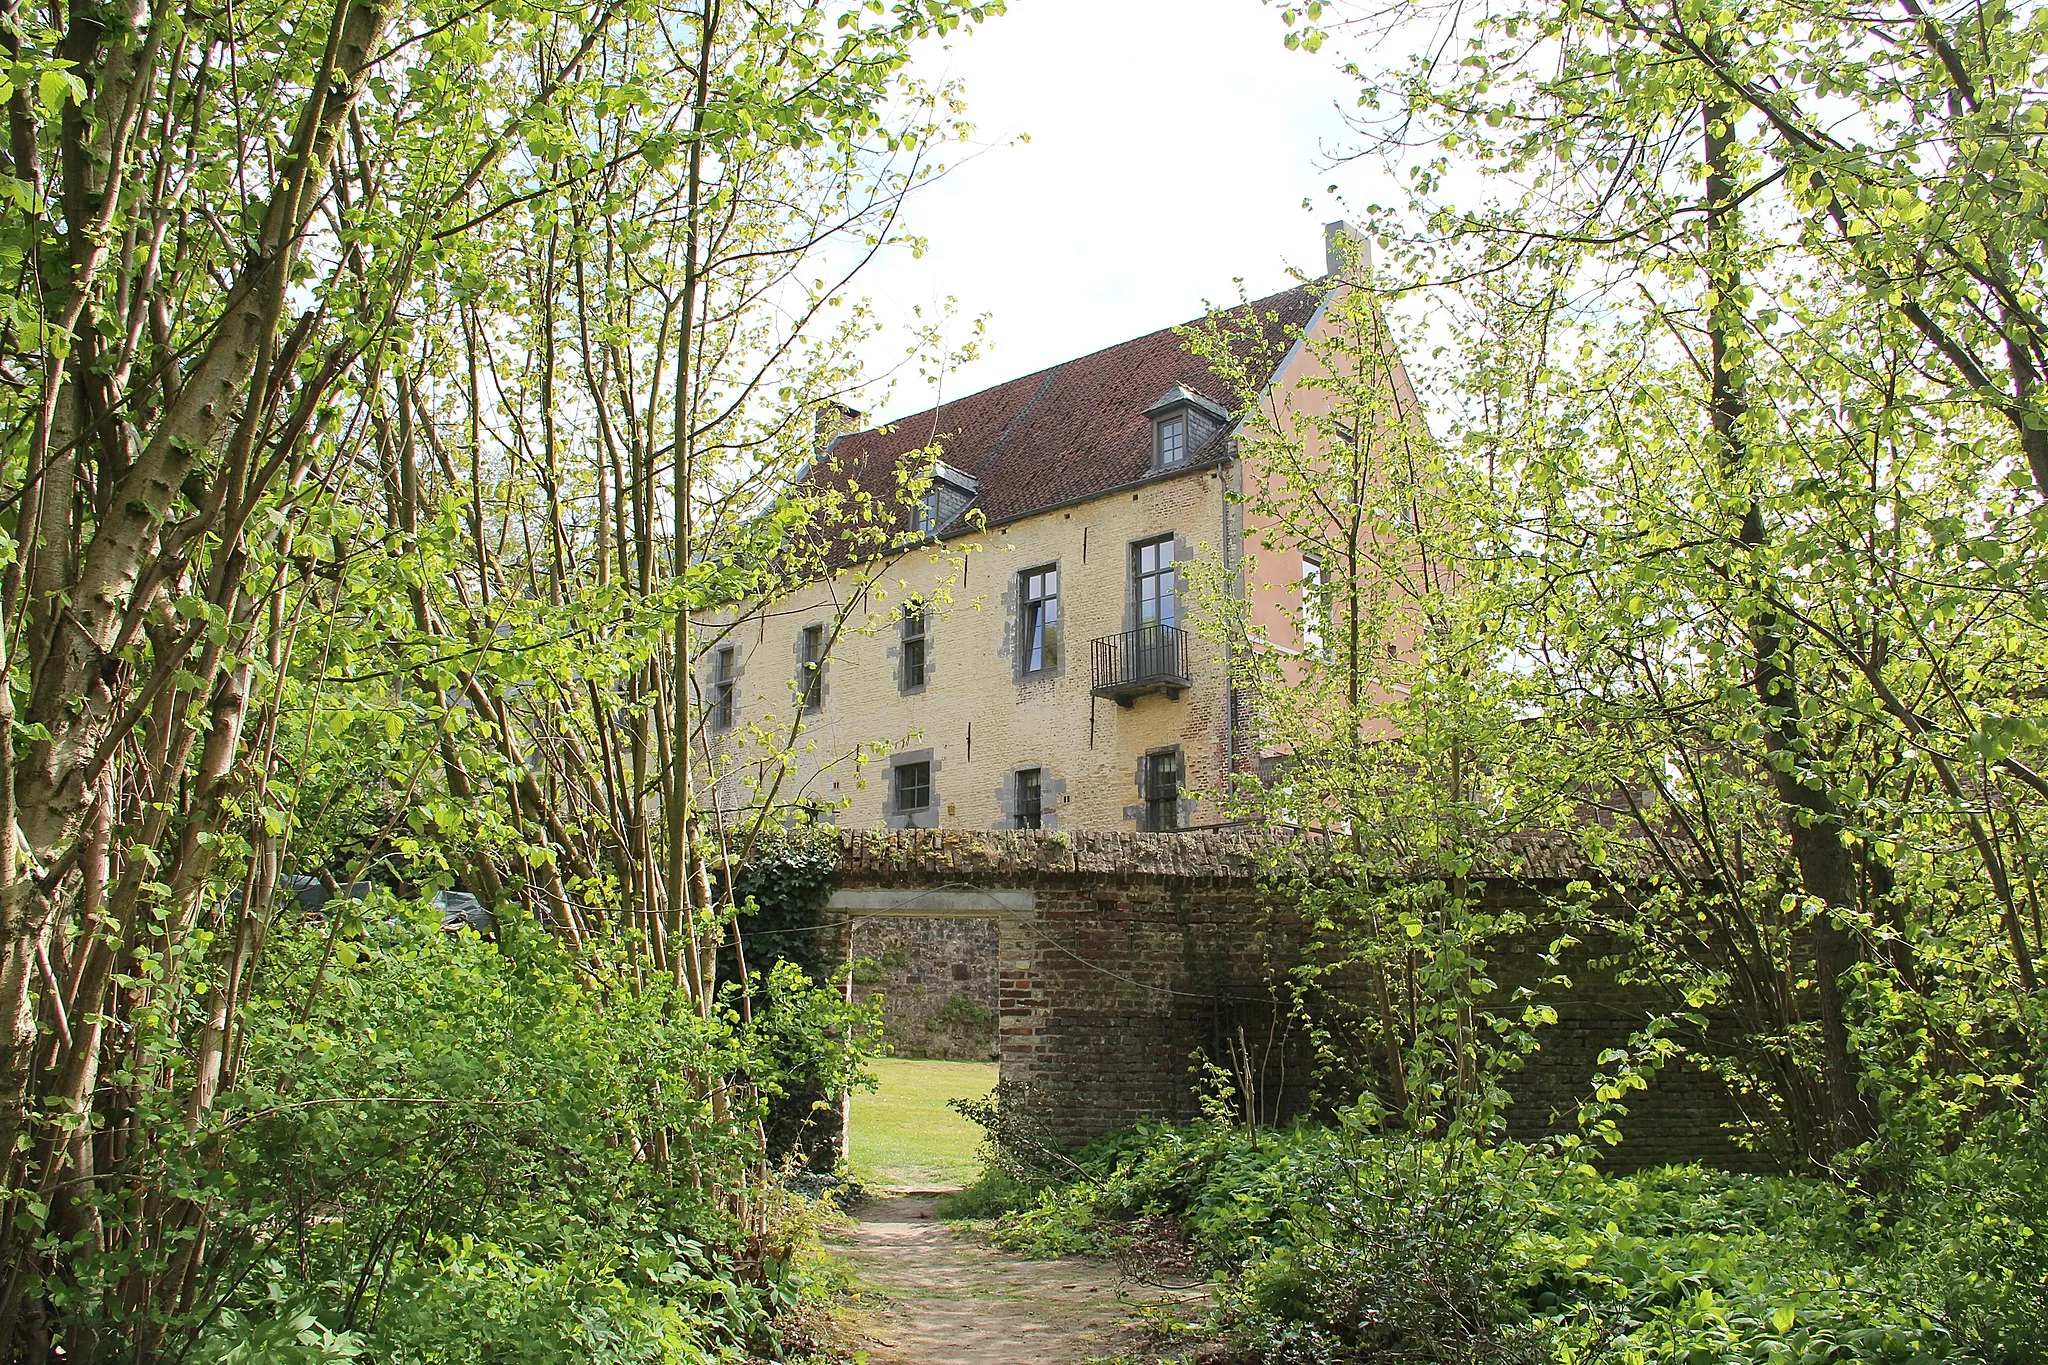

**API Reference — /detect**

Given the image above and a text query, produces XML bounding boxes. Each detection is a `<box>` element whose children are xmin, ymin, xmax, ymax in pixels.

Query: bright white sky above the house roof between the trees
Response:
<box><xmin>856</xmin><ymin>0</ymin><xmax>1389</xmax><ymax>417</ymax></box>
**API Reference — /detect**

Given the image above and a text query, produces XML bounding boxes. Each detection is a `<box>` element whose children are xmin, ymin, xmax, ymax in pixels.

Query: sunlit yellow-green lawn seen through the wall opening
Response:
<box><xmin>852</xmin><ymin>1058</ymin><xmax>995</xmax><ymax>1189</ymax></box>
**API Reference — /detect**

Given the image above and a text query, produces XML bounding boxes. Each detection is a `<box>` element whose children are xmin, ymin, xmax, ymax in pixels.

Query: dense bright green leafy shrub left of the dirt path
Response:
<box><xmin>55</xmin><ymin>902</ymin><xmax>850</xmax><ymax>1365</ymax></box>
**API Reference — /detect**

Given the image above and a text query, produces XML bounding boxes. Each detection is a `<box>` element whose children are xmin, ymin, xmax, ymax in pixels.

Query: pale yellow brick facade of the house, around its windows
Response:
<box><xmin>698</xmin><ymin>278</ymin><xmax>1359</xmax><ymax>831</ymax></box>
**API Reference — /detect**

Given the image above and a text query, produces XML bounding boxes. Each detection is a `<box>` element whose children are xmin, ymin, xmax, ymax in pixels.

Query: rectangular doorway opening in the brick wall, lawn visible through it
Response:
<box><xmin>825</xmin><ymin>886</ymin><xmax>1034</xmax><ymax>1189</ymax></box>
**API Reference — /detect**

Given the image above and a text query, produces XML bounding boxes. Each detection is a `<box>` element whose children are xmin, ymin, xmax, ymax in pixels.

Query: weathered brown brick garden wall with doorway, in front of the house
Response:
<box><xmin>838</xmin><ymin>831</ymin><xmax>1757</xmax><ymax>1166</ymax></box>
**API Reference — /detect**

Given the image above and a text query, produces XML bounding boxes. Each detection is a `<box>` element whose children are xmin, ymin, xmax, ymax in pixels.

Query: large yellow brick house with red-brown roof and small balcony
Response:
<box><xmin>696</xmin><ymin>223</ymin><xmax>1392</xmax><ymax>831</ymax></box>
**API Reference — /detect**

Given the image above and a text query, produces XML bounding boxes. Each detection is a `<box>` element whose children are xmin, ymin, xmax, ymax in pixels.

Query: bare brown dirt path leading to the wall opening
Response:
<box><xmin>840</xmin><ymin>1195</ymin><xmax>1186</xmax><ymax>1365</ymax></box>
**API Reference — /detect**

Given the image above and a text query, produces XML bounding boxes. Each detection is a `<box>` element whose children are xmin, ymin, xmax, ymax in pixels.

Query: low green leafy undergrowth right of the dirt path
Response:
<box><xmin>954</xmin><ymin>1115</ymin><xmax>2048</xmax><ymax>1365</ymax></box>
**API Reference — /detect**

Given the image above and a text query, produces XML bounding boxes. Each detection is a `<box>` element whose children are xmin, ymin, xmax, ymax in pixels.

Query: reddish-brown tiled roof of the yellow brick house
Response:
<box><xmin>813</xmin><ymin>284</ymin><xmax>1321</xmax><ymax>526</ymax></box>
